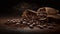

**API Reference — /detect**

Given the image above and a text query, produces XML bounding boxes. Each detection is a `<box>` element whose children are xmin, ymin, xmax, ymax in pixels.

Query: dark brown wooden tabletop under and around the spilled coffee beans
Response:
<box><xmin>0</xmin><ymin>18</ymin><xmax>60</xmax><ymax>34</ymax></box>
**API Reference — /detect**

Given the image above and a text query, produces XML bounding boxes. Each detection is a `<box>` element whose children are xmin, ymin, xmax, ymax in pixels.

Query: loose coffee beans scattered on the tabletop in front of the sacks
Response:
<box><xmin>5</xmin><ymin>18</ymin><xmax>56</xmax><ymax>29</ymax></box>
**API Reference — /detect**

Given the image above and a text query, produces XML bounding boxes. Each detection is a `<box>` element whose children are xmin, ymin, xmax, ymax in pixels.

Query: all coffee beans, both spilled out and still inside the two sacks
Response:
<box><xmin>5</xmin><ymin>8</ymin><xmax>56</xmax><ymax>29</ymax></box>
